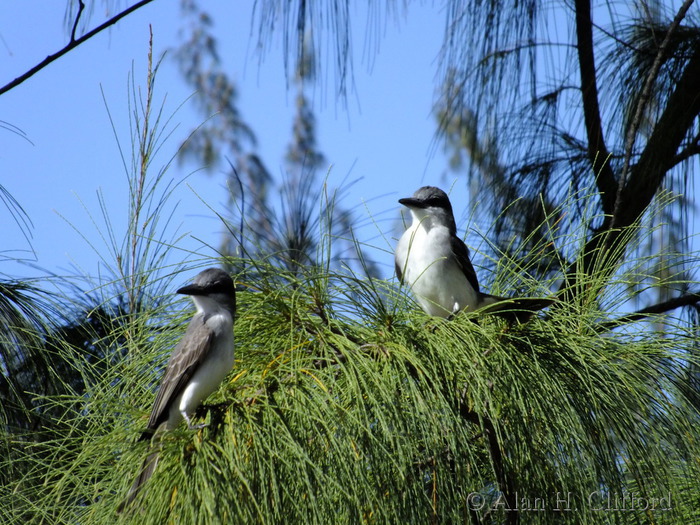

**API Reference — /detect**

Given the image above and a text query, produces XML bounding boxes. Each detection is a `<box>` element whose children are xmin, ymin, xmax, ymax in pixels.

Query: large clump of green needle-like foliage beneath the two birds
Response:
<box><xmin>0</xmin><ymin>263</ymin><xmax>700</xmax><ymax>524</ymax></box>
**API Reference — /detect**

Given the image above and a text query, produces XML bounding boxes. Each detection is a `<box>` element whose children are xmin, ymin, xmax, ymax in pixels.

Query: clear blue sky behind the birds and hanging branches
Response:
<box><xmin>0</xmin><ymin>0</ymin><xmax>476</xmax><ymax>284</ymax></box>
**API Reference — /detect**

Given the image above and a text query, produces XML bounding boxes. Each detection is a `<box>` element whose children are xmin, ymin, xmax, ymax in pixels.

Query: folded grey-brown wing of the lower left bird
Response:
<box><xmin>142</xmin><ymin>315</ymin><xmax>214</xmax><ymax>439</ymax></box>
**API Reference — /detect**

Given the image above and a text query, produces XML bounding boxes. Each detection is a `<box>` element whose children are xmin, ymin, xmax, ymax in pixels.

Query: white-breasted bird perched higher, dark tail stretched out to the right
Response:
<box><xmin>394</xmin><ymin>186</ymin><xmax>554</xmax><ymax>322</ymax></box>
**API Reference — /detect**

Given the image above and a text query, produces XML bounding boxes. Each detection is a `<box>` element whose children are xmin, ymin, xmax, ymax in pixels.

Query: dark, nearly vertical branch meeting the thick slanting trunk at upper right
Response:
<box><xmin>575</xmin><ymin>0</ymin><xmax>618</xmax><ymax>214</ymax></box>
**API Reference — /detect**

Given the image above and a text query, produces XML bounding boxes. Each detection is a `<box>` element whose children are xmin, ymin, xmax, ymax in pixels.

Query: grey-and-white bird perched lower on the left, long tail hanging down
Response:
<box><xmin>117</xmin><ymin>268</ymin><xmax>236</xmax><ymax>513</ymax></box>
